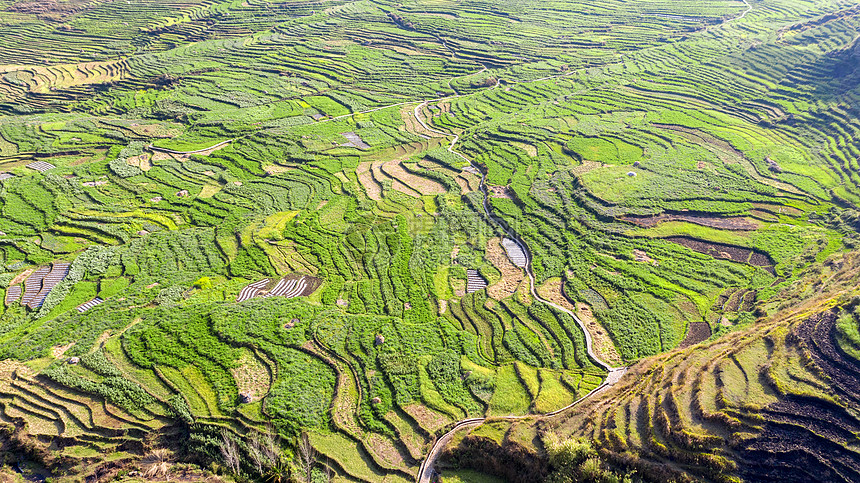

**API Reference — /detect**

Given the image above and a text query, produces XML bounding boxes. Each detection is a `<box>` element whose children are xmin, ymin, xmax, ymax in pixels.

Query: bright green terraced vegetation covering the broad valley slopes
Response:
<box><xmin>0</xmin><ymin>0</ymin><xmax>860</xmax><ymax>481</ymax></box>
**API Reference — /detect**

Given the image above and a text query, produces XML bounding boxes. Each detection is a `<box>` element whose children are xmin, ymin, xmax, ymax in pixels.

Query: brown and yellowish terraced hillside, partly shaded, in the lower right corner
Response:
<box><xmin>447</xmin><ymin>250</ymin><xmax>860</xmax><ymax>482</ymax></box>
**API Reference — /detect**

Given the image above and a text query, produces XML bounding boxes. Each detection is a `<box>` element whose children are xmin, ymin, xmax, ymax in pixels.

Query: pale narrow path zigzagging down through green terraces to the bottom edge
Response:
<box><xmin>413</xmin><ymin>85</ymin><xmax>627</xmax><ymax>483</ymax></box>
